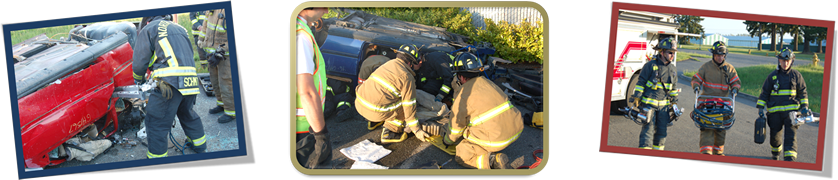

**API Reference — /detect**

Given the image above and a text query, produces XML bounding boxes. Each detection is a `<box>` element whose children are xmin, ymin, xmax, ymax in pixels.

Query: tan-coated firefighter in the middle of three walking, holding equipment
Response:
<box><xmin>690</xmin><ymin>41</ymin><xmax>742</xmax><ymax>156</ymax></box>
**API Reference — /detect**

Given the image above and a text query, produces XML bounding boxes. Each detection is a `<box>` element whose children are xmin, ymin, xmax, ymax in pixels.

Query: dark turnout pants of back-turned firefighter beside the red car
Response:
<box><xmin>145</xmin><ymin>88</ymin><xmax>206</xmax><ymax>158</ymax></box>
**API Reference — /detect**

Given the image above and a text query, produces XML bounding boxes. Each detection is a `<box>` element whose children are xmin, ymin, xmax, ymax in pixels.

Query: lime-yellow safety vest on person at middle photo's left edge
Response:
<box><xmin>297</xmin><ymin>17</ymin><xmax>326</xmax><ymax>134</ymax></box>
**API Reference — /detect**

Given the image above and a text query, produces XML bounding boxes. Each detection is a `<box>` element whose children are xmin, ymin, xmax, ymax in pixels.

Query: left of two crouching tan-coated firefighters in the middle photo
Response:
<box><xmin>355</xmin><ymin>45</ymin><xmax>428</xmax><ymax>143</ymax></box>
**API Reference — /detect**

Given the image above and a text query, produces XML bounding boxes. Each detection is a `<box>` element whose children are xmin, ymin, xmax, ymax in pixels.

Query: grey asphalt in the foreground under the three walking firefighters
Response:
<box><xmin>607</xmin><ymin>76</ymin><xmax>818</xmax><ymax>163</ymax></box>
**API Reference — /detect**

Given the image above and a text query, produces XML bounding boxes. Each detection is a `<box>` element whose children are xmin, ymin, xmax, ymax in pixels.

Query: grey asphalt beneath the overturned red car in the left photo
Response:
<box><xmin>46</xmin><ymin>77</ymin><xmax>239</xmax><ymax>169</ymax></box>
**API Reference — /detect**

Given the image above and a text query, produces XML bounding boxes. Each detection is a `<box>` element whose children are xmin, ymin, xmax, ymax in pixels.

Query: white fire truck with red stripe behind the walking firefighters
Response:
<box><xmin>611</xmin><ymin>10</ymin><xmax>701</xmax><ymax>109</ymax></box>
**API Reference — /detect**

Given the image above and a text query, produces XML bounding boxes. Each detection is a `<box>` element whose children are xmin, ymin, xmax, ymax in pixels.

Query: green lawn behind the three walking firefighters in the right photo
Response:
<box><xmin>732</xmin><ymin>64</ymin><xmax>823</xmax><ymax>112</ymax></box>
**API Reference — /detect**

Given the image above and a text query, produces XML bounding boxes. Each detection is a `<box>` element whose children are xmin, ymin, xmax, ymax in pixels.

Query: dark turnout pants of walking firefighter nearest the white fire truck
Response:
<box><xmin>639</xmin><ymin>106</ymin><xmax>670</xmax><ymax>150</ymax></box>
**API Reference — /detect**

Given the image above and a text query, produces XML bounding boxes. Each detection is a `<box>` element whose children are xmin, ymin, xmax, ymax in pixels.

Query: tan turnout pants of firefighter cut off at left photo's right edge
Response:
<box><xmin>208</xmin><ymin>57</ymin><xmax>236</xmax><ymax>117</ymax></box>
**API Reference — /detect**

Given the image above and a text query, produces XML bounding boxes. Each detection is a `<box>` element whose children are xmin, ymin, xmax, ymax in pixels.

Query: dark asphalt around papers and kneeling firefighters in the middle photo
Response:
<box><xmin>318</xmin><ymin>101</ymin><xmax>547</xmax><ymax>169</ymax></box>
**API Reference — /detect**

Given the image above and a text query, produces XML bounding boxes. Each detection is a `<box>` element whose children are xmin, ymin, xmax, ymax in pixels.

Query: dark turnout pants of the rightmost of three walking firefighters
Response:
<box><xmin>768</xmin><ymin>111</ymin><xmax>797</xmax><ymax>161</ymax></box>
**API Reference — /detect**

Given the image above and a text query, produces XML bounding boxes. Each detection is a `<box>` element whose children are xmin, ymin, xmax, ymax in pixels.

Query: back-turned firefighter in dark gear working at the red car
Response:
<box><xmin>133</xmin><ymin>16</ymin><xmax>207</xmax><ymax>158</ymax></box>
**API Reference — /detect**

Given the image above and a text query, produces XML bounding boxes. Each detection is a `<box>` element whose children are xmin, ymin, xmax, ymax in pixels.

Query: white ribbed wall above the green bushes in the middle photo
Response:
<box><xmin>461</xmin><ymin>7</ymin><xmax>543</xmax><ymax>28</ymax></box>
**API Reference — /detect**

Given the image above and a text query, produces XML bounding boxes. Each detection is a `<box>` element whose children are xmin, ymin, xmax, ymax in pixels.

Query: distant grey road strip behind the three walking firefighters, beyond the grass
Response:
<box><xmin>676</xmin><ymin>49</ymin><xmax>824</xmax><ymax>74</ymax></box>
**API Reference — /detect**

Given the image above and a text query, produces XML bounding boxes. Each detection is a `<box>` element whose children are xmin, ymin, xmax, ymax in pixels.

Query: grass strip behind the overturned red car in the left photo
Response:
<box><xmin>11</xmin><ymin>13</ymin><xmax>208</xmax><ymax>73</ymax></box>
